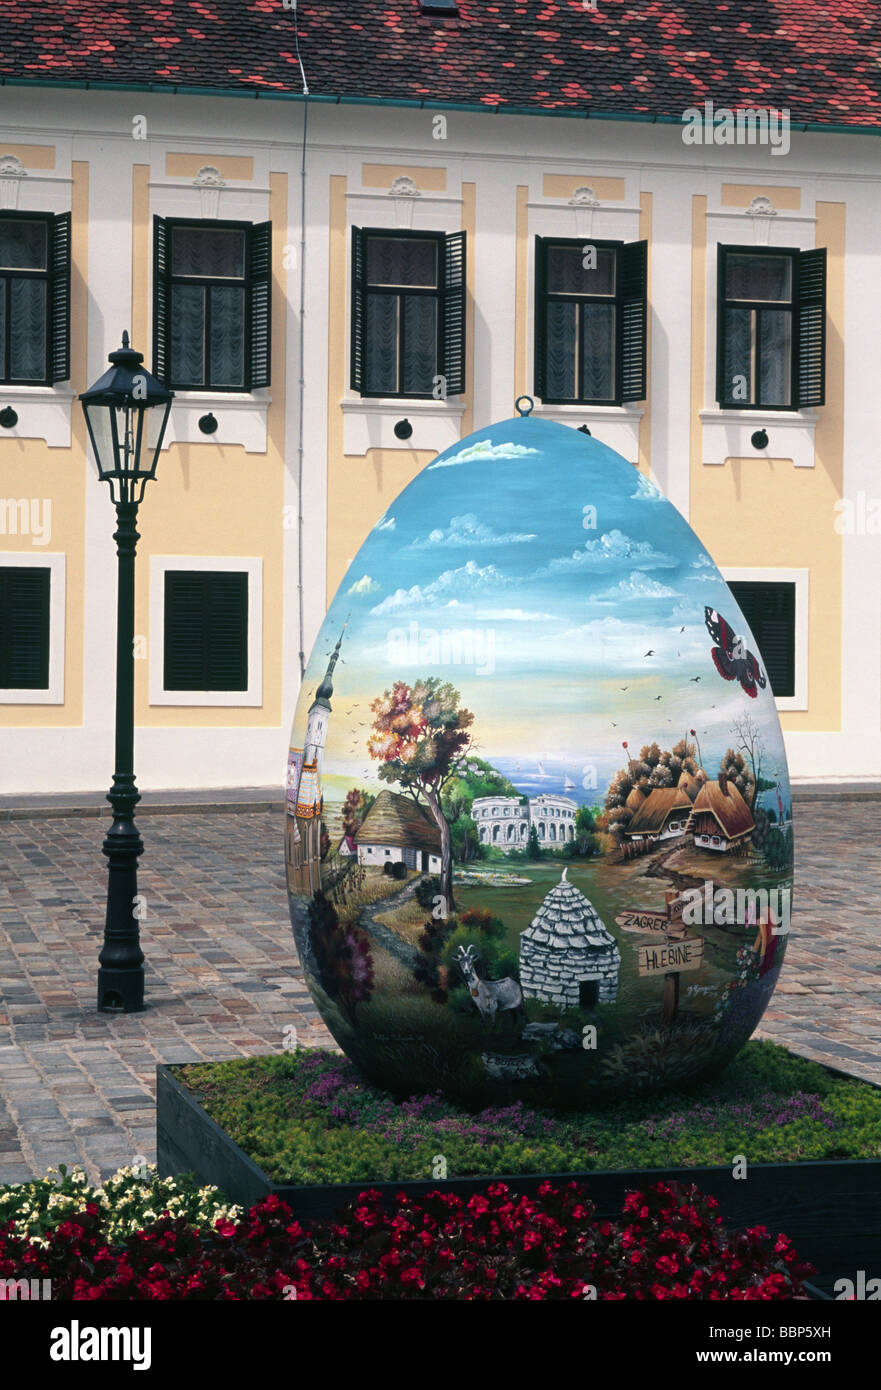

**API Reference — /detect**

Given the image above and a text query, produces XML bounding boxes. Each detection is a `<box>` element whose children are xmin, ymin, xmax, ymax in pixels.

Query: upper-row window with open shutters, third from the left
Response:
<box><xmin>352</xmin><ymin>227</ymin><xmax>466</xmax><ymax>399</ymax></box>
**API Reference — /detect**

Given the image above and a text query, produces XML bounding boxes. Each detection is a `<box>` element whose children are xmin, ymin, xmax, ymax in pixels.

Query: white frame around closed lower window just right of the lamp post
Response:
<box><xmin>147</xmin><ymin>555</ymin><xmax>263</xmax><ymax>709</ymax></box>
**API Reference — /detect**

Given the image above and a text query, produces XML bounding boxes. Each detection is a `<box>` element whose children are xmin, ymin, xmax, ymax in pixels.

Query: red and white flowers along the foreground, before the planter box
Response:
<box><xmin>0</xmin><ymin>1170</ymin><xmax>812</xmax><ymax>1301</ymax></box>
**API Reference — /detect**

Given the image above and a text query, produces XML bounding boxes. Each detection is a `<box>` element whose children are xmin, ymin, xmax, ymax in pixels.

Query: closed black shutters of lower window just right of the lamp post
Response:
<box><xmin>163</xmin><ymin>570</ymin><xmax>247</xmax><ymax>691</ymax></box>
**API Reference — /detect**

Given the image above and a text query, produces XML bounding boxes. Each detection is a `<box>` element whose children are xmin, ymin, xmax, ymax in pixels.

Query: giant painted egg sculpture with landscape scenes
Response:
<box><xmin>285</xmin><ymin>405</ymin><xmax>792</xmax><ymax>1108</ymax></box>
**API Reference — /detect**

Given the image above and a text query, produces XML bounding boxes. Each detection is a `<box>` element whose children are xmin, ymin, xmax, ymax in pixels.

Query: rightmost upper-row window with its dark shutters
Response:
<box><xmin>716</xmin><ymin>246</ymin><xmax>825</xmax><ymax>410</ymax></box>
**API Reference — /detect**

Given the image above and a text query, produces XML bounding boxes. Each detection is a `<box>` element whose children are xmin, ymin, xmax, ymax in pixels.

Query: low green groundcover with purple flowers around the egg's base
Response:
<box><xmin>175</xmin><ymin>1041</ymin><xmax>881</xmax><ymax>1184</ymax></box>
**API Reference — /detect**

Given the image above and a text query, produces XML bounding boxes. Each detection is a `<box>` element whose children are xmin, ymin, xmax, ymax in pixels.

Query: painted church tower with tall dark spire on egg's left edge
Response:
<box><xmin>285</xmin><ymin>626</ymin><xmax>346</xmax><ymax>897</ymax></box>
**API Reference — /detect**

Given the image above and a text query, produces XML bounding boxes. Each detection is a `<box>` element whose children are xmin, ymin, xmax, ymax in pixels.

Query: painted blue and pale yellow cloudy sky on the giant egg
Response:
<box><xmin>295</xmin><ymin>418</ymin><xmax>787</xmax><ymax>801</ymax></box>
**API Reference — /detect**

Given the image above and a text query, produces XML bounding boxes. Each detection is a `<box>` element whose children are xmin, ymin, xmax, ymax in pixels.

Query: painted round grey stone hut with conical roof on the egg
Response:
<box><xmin>520</xmin><ymin>869</ymin><xmax>621</xmax><ymax>1009</ymax></box>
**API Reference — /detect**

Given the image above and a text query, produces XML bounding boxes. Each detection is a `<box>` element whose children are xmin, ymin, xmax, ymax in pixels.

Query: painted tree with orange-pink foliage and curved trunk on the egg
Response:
<box><xmin>367</xmin><ymin>676</ymin><xmax>474</xmax><ymax>902</ymax></box>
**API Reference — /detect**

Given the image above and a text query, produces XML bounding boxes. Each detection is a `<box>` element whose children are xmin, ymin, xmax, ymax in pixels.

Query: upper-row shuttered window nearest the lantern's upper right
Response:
<box><xmin>153</xmin><ymin>217</ymin><xmax>272</xmax><ymax>391</ymax></box>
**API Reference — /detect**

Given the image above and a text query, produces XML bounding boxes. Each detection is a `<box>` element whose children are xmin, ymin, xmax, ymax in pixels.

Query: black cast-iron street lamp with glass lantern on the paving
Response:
<box><xmin>79</xmin><ymin>334</ymin><xmax>174</xmax><ymax>1013</ymax></box>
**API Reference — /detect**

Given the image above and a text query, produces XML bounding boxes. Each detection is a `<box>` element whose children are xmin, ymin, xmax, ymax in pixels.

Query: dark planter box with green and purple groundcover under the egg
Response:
<box><xmin>157</xmin><ymin>1043</ymin><xmax>881</xmax><ymax>1294</ymax></box>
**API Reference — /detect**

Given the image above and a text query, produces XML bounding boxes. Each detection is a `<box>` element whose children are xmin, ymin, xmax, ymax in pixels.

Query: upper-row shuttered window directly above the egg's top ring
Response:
<box><xmin>535</xmin><ymin>236</ymin><xmax>648</xmax><ymax>406</ymax></box>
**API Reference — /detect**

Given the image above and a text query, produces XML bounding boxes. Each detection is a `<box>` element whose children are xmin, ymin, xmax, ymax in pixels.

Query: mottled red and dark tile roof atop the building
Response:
<box><xmin>0</xmin><ymin>0</ymin><xmax>881</xmax><ymax>129</ymax></box>
